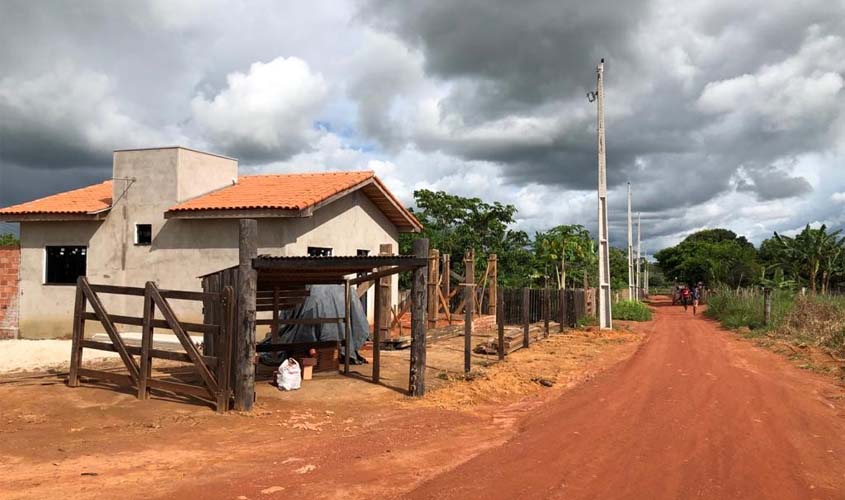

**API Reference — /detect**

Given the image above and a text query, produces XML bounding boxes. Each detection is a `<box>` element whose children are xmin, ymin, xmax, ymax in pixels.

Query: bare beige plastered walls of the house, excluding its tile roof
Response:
<box><xmin>15</xmin><ymin>148</ymin><xmax>399</xmax><ymax>338</ymax></box>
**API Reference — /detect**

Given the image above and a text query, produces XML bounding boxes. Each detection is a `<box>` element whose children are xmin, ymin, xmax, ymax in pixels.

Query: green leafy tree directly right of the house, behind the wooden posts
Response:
<box><xmin>399</xmin><ymin>189</ymin><xmax>533</xmax><ymax>287</ymax></box>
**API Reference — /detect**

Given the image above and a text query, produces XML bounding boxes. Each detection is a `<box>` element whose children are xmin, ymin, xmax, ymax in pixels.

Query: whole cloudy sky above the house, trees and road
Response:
<box><xmin>0</xmin><ymin>0</ymin><xmax>845</xmax><ymax>253</ymax></box>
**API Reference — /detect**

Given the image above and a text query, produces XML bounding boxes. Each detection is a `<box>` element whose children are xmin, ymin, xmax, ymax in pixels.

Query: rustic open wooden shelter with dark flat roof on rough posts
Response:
<box><xmin>201</xmin><ymin>219</ymin><xmax>429</xmax><ymax>411</ymax></box>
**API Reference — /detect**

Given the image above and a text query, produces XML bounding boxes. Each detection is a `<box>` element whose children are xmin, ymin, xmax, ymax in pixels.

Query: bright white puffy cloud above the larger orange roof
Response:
<box><xmin>191</xmin><ymin>57</ymin><xmax>328</xmax><ymax>159</ymax></box>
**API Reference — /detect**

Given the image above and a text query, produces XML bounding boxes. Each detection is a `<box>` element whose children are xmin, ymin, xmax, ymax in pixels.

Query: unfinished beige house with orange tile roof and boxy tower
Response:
<box><xmin>0</xmin><ymin>147</ymin><xmax>421</xmax><ymax>338</ymax></box>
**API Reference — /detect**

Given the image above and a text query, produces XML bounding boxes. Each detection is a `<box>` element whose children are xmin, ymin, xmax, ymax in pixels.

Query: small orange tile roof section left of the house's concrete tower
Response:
<box><xmin>0</xmin><ymin>181</ymin><xmax>112</xmax><ymax>216</ymax></box>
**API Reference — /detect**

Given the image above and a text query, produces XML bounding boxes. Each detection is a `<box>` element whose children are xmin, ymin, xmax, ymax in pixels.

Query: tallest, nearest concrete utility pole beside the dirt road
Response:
<box><xmin>587</xmin><ymin>59</ymin><xmax>613</xmax><ymax>330</ymax></box>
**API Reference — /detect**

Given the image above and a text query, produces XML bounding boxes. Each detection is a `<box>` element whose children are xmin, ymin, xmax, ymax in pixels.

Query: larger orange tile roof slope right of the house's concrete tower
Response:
<box><xmin>168</xmin><ymin>171</ymin><xmax>375</xmax><ymax>212</ymax></box>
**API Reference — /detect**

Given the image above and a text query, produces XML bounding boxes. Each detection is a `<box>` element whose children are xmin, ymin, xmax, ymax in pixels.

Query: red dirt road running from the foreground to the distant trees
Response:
<box><xmin>407</xmin><ymin>302</ymin><xmax>845</xmax><ymax>499</ymax></box>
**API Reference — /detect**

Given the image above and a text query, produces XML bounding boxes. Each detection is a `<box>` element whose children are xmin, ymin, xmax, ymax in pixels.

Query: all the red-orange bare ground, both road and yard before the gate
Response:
<box><xmin>0</xmin><ymin>300</ymin><xmax>845</xmax><ymax>500</ymax></box>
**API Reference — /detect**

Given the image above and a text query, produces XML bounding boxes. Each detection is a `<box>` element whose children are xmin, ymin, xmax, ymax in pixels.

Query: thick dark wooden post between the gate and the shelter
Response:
<box><xmin>234</xmin><ymin>219</ymin><xmax>258</xmax><ymax>411</ymax></box>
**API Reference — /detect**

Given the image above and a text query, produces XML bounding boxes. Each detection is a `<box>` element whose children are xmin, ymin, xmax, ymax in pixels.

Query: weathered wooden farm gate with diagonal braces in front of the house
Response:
<box><xmin>68</xmin><ymin>276</ymin><xmax>235</xmax><ymax>411</ymax></box>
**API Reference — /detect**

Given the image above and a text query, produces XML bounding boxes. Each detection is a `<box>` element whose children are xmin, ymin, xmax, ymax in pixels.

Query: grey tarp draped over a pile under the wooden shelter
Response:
<box><xmin>261</xmin><ymin>285</ymin><xmax>370</xmax><ymax>365</ymax></box>
